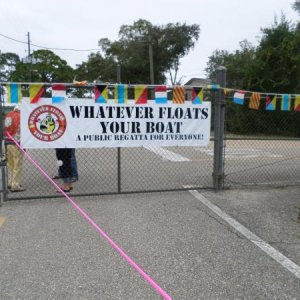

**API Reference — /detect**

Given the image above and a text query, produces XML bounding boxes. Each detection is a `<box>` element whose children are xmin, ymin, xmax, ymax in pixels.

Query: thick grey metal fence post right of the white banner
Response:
<box><xmin>213</xmin><ymin>66</ymin><xmax>226</xmax><ymax>192</ymax></box>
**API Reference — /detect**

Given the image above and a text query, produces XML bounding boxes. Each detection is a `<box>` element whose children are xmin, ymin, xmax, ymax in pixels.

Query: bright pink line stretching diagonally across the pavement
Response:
<box><xmin>7</xmin><ymin>133</ymin><xmax>172</xmax><ymax>300</ymax></box>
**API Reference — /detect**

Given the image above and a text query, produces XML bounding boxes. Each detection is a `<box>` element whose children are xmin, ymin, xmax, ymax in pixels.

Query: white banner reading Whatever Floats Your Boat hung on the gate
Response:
<box><xmin>21</xmin><ymin>98</ymin><xmax>211</xmax><ymax>148</ymax></box>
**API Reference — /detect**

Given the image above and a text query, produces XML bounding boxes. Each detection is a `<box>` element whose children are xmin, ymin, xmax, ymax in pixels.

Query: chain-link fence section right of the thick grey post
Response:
<box><xmin>224</xmin><ymin>95</ymin><xmax>300</xmax><ymax>187</ymax></box>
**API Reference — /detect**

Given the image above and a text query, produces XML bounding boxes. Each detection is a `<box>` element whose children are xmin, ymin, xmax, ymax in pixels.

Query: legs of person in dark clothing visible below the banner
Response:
<box><xmin>56</xmin><ymin>148</ymin><xmax>73</xmax><ymax>193</ymax></box>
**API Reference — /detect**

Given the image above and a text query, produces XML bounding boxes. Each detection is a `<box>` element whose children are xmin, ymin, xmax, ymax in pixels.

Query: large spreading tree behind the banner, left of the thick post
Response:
<box><xmin>76</xmin><ymin>19</ymin><xmax>200</xmax><ymax>83</ymax></box>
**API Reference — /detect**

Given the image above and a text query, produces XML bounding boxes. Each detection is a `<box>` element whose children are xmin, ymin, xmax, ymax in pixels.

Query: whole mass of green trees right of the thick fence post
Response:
<box><xmin>206</xmin><ymin>16</ymin><xmax>300</xmax><ymax>93</ymax></box>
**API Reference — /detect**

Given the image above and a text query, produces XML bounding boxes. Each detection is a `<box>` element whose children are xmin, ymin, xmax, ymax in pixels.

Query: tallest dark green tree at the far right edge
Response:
<box><xmin>251</xmin><ymin>16</ymin><xmax>300</xmax><ymax>93</ymax></box>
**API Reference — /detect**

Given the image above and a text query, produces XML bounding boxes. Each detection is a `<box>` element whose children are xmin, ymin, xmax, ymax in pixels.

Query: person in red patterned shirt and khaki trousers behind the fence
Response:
<box><xmin>4</xmin><ymin>105</ymin><xmax>25</xmax><ymax>192</ymax></box>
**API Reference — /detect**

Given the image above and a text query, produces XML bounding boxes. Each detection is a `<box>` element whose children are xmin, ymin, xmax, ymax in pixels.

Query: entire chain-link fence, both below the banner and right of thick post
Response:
<box><xmin>1</xmin><ymin>70</ymin><xmax>300</xmax><ymax>200</ymax></box>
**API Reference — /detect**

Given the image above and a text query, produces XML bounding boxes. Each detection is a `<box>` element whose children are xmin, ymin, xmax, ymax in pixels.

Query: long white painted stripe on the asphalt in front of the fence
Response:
<box><xmin>190</xmin><ymin>190</ymin><xmax>300</xmax><ymax>279</ymax></box>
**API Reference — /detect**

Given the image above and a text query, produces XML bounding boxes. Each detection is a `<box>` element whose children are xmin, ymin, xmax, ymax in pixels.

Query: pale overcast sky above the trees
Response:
<box><xmin>0</xmin><ymin>0</ymin><xmax>299</xmax><ymax>83</ymax></box>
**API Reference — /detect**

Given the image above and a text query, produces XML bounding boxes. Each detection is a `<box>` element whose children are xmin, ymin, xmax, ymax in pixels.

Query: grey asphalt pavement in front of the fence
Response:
<box><xmin>0</xmin><ymin>186</ymin><xmax>300</xmax><ymax>300</ymax></box>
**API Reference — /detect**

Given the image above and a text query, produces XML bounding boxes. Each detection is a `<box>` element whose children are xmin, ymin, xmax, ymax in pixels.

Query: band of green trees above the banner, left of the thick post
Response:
<box><xmin>0</xmin><ymin>19</ymin><xmax>200</xmax><ymax>84</ymax></box>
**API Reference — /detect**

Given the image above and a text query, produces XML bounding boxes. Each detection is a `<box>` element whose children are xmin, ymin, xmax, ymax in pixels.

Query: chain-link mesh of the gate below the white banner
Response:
<box><xmin>1</xmin><ymin>70</ymin><xmax>223</xmax><ymax>200</ymax></box>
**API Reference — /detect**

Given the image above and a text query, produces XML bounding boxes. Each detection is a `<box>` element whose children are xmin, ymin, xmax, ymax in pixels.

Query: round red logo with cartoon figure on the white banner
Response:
<box><xmin>28</xmin><ymin>105</ymin><xmax>67</xmax><ymax>142</ymax></box>
